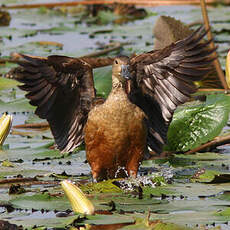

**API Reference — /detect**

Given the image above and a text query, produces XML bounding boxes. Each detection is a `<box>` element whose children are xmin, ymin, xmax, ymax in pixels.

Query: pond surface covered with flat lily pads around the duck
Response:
<box><xmin>0</xmin><ymin>0</ymin><xmax>230</xmax><ymax>229</ymax></box>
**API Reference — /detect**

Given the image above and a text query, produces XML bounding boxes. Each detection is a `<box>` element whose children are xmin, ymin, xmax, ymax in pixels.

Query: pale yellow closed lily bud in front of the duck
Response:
<box><xmin>61</xmin><ymin>180</ymin><xmax>94</xmax><ymax>215</ymax></box>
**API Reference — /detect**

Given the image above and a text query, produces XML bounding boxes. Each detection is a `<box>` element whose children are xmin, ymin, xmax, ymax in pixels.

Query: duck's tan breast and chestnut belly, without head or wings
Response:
<box><xmin>85</xmin><ymin>89</ymin><xmax>146</xmax><ymax>179</ymax></box>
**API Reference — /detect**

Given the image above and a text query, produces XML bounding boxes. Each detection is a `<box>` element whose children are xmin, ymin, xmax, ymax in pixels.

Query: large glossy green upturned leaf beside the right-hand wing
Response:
<box><xmin>166</xmin><ymin>94</ymin><xmax>230</xmax><ymax>151</ymax></box>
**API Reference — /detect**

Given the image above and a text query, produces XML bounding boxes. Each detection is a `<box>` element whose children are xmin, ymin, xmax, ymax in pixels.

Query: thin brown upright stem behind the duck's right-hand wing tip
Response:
<box><xmin>200</xmin><ymin>0</ymin><xmax>228</xmax><ymax>90</ymax></box>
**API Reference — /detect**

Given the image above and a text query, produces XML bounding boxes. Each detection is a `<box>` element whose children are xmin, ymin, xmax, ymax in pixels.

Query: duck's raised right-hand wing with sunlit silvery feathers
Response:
<box><xmin>129</xmin><ymin>27</ymin><xmax>215</xmax><ymax>152</ymax></box>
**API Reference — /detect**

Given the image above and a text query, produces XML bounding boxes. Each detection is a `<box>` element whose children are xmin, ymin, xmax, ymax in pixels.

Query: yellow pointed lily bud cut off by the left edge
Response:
<box><xmin>0</xmin><ymin>114</ymin><xmax>13</xmax><ymax>146</ymax></box>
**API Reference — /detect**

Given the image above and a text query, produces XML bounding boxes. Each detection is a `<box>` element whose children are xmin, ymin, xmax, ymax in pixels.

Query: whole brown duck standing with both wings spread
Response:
<box><xmin>13</xmin><ymin>28</ymin><xmax>214</xmax><ymax>179</ymax></box>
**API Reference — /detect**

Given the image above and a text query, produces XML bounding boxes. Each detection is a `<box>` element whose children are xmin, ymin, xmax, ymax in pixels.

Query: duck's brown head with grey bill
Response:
<box><xmin>112</xmin><ymin>56</ymin><xmax>131</xmax><ymax>85</ymax></box>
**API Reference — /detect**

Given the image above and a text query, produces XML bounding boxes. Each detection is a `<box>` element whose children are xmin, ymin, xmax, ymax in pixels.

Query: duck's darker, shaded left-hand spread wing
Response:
<box><xmin>15</xmin><ymin>54</ymin><xmax>95</xmax><ymax>152</ymax></box>
